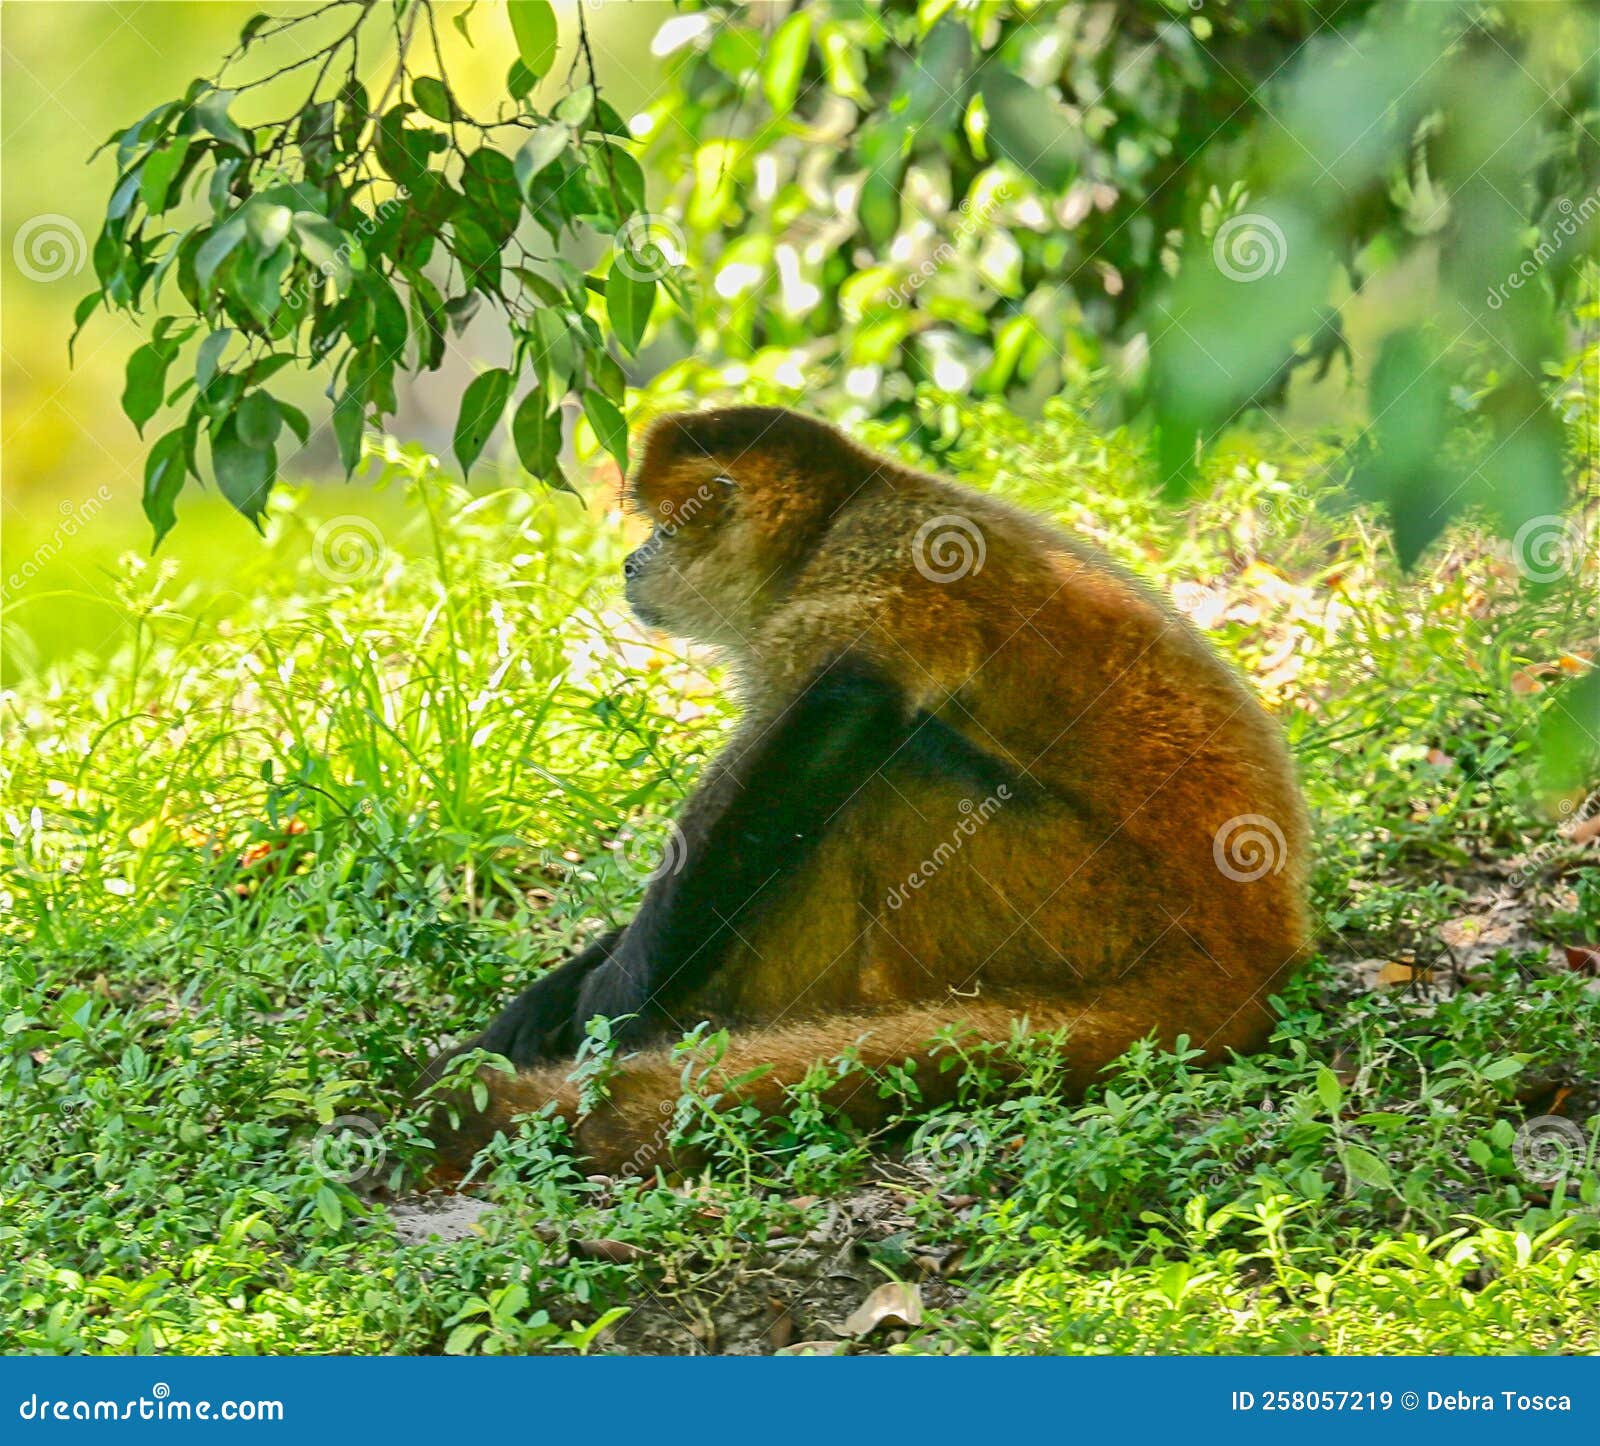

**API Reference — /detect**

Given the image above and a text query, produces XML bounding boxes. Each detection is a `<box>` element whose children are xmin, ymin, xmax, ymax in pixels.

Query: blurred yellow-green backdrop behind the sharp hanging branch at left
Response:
<box><xmin>0</xmin><ymin>0</ymin><xmax>667</xmax><ymax>683</ymax></box>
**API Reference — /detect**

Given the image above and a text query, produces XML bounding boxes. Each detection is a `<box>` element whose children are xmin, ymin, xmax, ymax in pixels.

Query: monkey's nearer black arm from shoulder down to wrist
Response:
<box><xmin>578</xmin><ymin>656</ymin><xmax>942</xmax><ymax>1038</ymax></box>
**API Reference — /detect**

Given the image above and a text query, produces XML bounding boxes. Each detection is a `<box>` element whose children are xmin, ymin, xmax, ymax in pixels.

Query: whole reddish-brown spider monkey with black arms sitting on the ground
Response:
<box><xmin>424</xmin><ymin>406</ymin><xmax>1309</xmax><ymax>1169</ymax></box>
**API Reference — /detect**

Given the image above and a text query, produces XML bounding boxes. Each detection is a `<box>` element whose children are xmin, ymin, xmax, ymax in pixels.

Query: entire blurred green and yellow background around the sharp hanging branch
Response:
<box><xmin>0</xmin><ymin>0</ymin><xmax>1600</xmax><ymax>680</ymax></box>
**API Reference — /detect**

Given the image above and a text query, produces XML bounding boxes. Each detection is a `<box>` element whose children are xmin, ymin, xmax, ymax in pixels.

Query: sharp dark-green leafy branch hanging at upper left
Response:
<box><xmin>77</xmin><ymin>0</ymin><xmax>674</xmax><ymax>542</ymax></box>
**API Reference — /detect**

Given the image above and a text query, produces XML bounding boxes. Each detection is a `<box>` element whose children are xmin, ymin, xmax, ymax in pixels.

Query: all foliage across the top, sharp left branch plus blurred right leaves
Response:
<box><xmin>78</xmin><ymin>0</ymin><xmax>1600</xmax><ymax>561</ymax></box>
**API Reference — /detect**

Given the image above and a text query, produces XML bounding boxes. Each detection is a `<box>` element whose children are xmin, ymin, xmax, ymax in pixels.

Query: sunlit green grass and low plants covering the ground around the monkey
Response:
<box><xmin>0</xmin><ymin>390</ymin><xmax>1600</xmax><ymax>1352</ymax></box>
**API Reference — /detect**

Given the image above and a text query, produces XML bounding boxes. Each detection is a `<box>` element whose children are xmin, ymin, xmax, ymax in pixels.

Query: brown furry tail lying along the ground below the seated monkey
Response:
<box><xmin>422</xmin><ymin>981</ymin><xmax>1274</xmax><ymax>1179</ymax></box>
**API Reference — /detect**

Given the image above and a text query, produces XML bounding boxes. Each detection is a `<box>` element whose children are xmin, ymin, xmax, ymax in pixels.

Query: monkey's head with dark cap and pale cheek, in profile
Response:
<box><xmin>622</xmin><ymin>406</ymin><xmax>882</xmax><ymax>648</ymax></box>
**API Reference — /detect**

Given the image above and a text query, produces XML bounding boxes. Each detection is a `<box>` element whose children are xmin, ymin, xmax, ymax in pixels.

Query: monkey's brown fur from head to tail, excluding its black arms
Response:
<box><xmin>428</xmin><ymin>408</ymin><xmax>1309</xmax><ymax>1168</ymax></box>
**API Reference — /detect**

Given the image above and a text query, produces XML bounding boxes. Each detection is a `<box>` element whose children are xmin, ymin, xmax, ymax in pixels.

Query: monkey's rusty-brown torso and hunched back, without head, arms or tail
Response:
<box><xmin>702</xmin><ymin>472</ymin><xmax>1309</xmax><ymax>1046</ymax></box>
